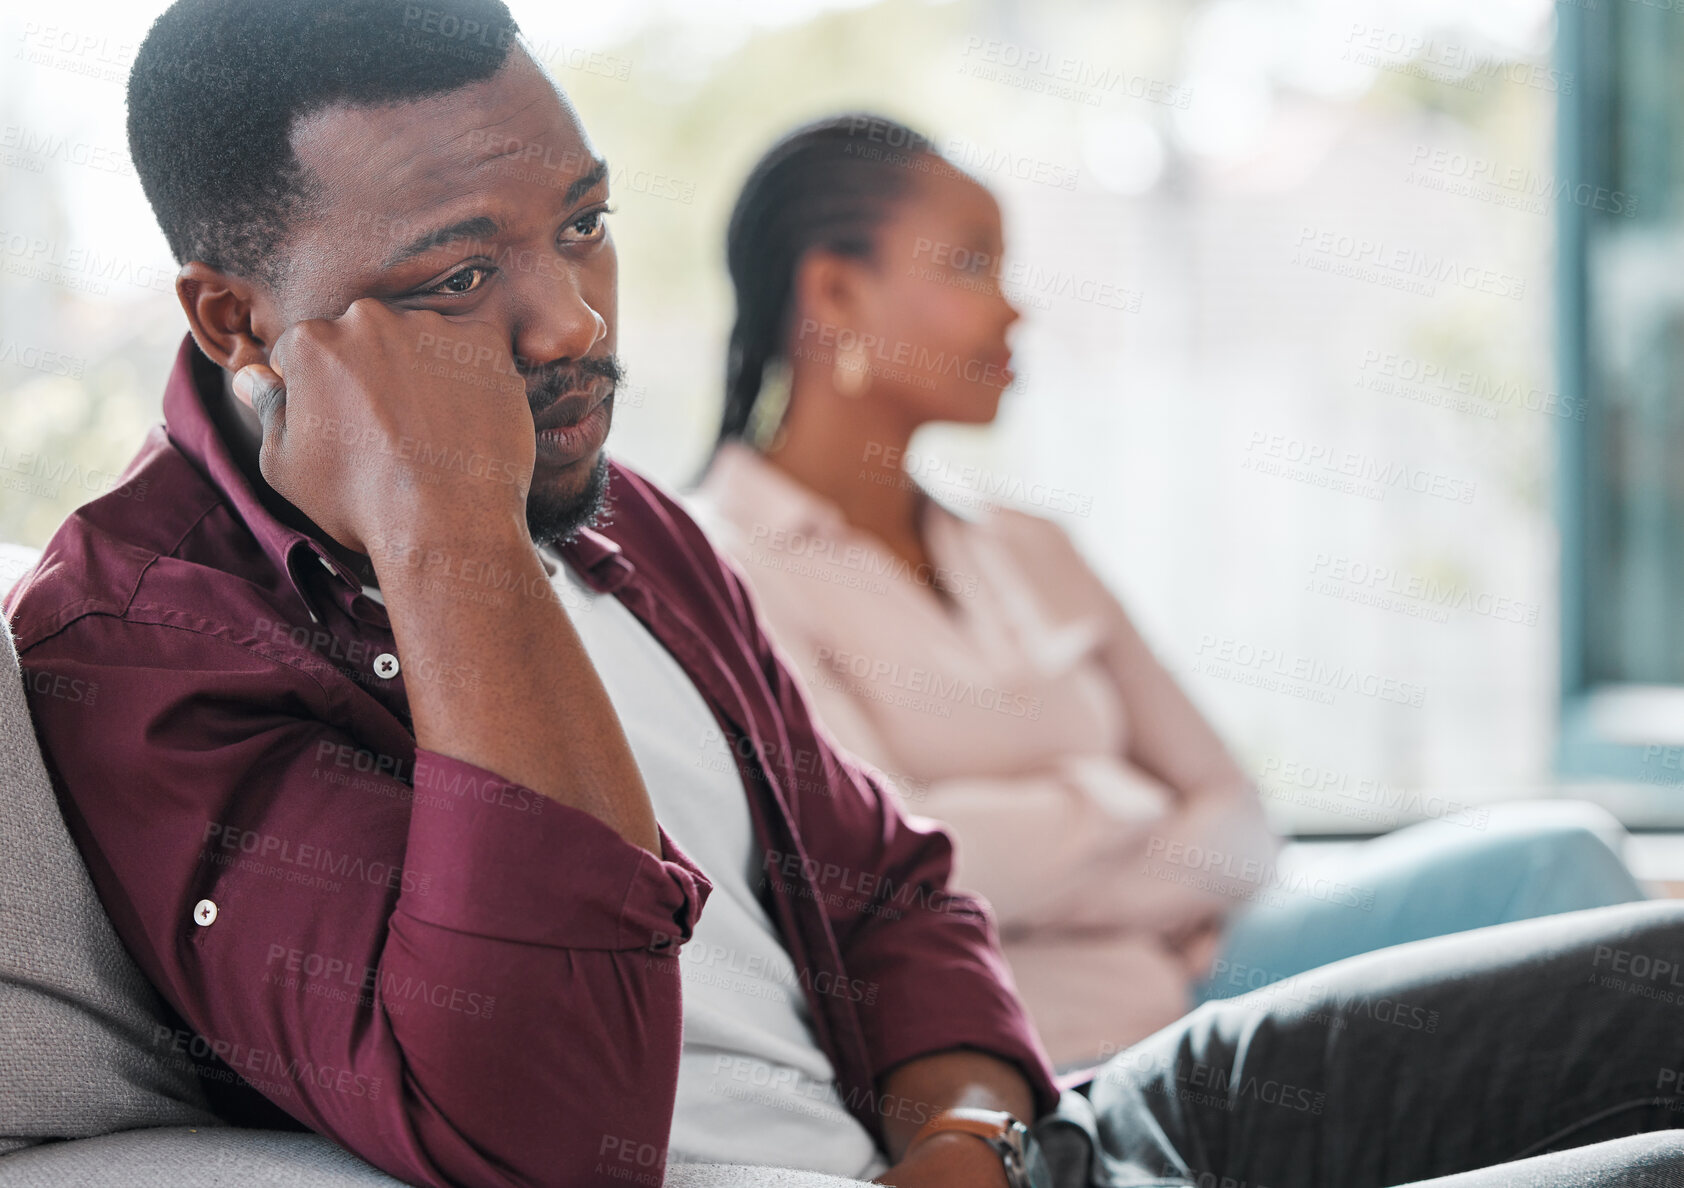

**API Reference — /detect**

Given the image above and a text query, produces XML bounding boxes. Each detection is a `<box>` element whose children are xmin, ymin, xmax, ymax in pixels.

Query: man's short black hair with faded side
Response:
<box><xmin>128</xmin><ymin>0</ymin><xmax>520</xmax><ymax>285</ymax></box>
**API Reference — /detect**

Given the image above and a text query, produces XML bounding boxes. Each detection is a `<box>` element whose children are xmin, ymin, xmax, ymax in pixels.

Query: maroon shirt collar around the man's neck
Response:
<box><xmin>163</xmin><ymin>334</ymin><xmax>632</xmax><ymax>617</ymax></box>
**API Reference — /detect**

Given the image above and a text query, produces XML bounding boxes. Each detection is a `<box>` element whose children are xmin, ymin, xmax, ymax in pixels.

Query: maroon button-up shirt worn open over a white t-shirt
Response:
<box><xmin>5</xmin><ymin>339</ymin><xmax>1056</xmax><ymax>1185</ymax></box>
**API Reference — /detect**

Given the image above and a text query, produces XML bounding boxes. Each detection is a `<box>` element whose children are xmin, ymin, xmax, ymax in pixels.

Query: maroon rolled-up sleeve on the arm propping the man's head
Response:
<box><xmin>24</xmin><ymin>617</ymin><xmax>709</xmax><ymax>1188</ymax></box>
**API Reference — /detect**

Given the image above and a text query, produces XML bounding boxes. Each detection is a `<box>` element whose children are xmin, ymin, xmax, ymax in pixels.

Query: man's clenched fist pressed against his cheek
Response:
<box><xmin>234</xmin><ymin>298</ymin><xmax>537</xmax><ymax>553</ymax></box>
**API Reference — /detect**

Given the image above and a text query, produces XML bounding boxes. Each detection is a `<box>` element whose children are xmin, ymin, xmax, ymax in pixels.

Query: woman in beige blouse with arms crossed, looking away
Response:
<box><xmin>695</xmin><ymin>115</ymin><xmax>1642</xmax><ymax>1065</ymax></box>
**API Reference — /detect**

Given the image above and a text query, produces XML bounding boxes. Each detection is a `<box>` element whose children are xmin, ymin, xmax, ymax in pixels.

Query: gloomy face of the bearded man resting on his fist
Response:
<box><xmin>271</xmin><ymin>47</ymin><xmax>620</xmax><ymax>544</ymax></box>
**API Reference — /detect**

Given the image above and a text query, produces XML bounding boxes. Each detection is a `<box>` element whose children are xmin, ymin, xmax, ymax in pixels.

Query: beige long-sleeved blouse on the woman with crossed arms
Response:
<box><xmin>692</xmin><ymin>445</ymin><xmax>1275</xmax><ymax>1063</ymax></box>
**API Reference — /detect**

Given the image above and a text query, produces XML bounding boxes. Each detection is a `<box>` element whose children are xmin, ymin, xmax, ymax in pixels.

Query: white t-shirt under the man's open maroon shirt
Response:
<box><xmin>369</xmin><ymin>549</ymin><xmax>887</xmax><ymax>1180</ymax></box>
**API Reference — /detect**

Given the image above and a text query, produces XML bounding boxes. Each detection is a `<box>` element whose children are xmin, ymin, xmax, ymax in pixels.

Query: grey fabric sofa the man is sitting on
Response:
<box><xmin>0</xmin><ymin>544</ymin><xmax>882</xmax><ymax>1188</ymax></box>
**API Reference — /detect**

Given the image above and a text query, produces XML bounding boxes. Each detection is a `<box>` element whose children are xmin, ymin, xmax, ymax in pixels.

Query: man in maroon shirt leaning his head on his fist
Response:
<box><xmin>7</xmin><ymin>0</ymin><xmax>1684</xmax><ymax>1188</ymax></box>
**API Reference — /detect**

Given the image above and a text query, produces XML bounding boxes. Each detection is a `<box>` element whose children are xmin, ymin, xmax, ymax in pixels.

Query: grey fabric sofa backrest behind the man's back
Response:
<box><xmin>0</xmin><ymin>544</ymin><xmax>219</xmax><ymax>1154</ymax></box>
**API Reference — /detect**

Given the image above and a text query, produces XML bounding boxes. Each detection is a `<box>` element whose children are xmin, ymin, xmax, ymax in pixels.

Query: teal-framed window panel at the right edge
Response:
<box><xmin>1554</xmin><ymin>0</ymin><xmax>1684</xmax><ymax>789</ymax></box>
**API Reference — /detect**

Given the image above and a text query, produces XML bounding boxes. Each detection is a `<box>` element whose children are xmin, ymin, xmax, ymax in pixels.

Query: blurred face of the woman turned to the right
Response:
<box><xmin>861</xmin><ymin>158</ymin><xmax>1019</xmax><ymax>425</ymax></box>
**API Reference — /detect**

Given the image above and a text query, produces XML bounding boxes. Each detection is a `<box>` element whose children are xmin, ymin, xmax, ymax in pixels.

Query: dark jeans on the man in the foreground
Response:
<box><xmin>1034</xmin><ymin>902</ymin><xmax>1684</xmax><ymax>1188</ymax></box>
